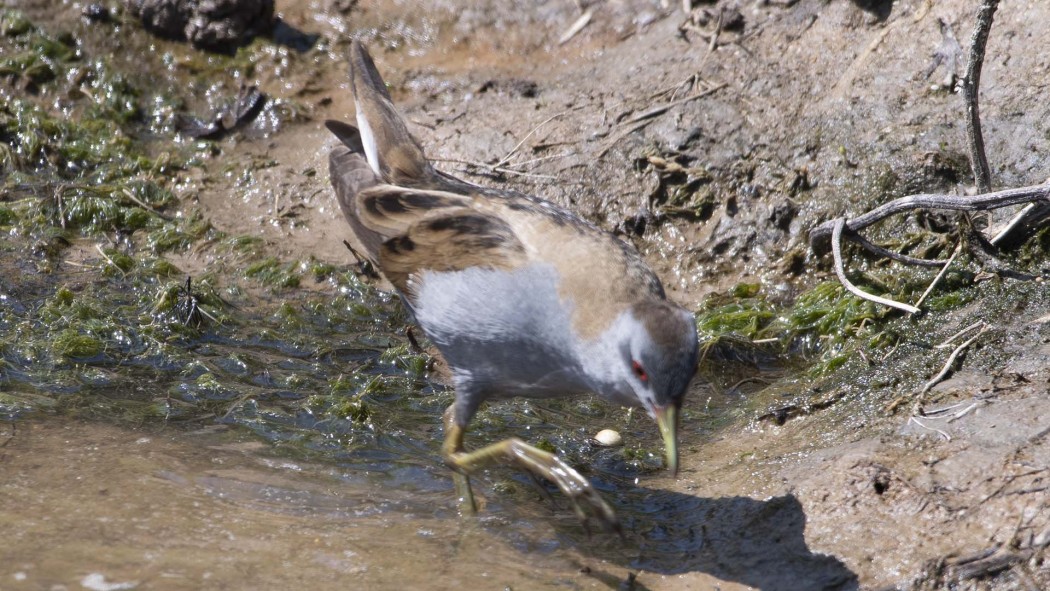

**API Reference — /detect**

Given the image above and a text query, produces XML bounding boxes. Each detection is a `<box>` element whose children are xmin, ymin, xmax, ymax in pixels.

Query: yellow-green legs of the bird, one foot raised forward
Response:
<box><xmin>442</xmin><ymin>409</ymin><xmax>621</xmax><ymax>531</ymax></box>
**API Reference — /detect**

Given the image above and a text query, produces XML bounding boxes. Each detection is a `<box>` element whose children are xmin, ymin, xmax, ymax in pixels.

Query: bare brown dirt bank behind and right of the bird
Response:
<box><xmin>2</xmin><ymin>0</ymin><xmax>1050</xmax><ymax>590</ymax></box>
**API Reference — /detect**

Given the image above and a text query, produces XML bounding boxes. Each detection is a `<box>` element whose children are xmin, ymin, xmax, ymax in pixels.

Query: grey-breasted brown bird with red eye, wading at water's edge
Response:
<box><xmin>326</xmin><ymin>40</ymin><xmax>699</xmax><ymax>533</ymax></box>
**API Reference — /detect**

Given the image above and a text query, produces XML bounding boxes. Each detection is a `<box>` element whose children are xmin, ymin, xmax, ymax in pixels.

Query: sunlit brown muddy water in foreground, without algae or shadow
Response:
<box><xmin>0</xmin><ymin>419</ymin><xmax>591</xmax><ymax>589</ymax></box>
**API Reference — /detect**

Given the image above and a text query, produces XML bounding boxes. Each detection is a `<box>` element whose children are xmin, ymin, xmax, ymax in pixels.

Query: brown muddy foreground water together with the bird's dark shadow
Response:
<box><xmin>0</xmin><ymin>411</ymin><xmax>849</xmax><ymax>589</ymax></box>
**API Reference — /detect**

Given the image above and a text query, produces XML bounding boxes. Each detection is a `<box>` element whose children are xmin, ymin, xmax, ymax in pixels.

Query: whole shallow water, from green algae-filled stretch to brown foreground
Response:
<box><xmin>0</xmin><ymin>229</ymin><xmax>814</xmax><ymax>589</ymax></box>
